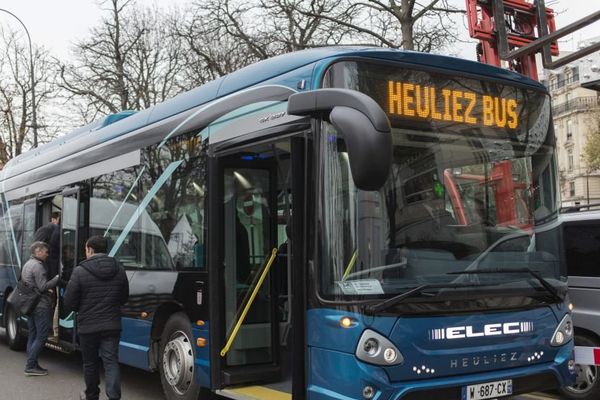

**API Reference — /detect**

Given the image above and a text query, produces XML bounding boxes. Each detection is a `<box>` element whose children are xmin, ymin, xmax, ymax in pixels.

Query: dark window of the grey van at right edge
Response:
<box><xmin>563</xmin><ymin>224</ymin><xmax>600</xmax><ymax>277</ymax></box>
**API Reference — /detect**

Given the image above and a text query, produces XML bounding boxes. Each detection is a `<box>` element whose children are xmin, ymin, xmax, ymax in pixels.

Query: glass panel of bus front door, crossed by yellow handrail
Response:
<box><xmin>223</xmin><ymin>168</ymin><xmax>273</xmax><ymax>366</ymax></box>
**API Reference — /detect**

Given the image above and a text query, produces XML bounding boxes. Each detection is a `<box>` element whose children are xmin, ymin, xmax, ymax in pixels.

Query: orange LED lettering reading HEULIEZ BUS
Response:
<box><xmin>386</xmin><ymin>80</ymin><xmax>519</xmax><ymax>129</ymax></box>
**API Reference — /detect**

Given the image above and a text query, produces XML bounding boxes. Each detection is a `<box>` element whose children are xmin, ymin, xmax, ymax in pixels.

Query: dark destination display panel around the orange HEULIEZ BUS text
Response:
<box><xmin>323</xmin><ymin>61</ymin><xmax>550</xmax><ymax>139</ymax></box>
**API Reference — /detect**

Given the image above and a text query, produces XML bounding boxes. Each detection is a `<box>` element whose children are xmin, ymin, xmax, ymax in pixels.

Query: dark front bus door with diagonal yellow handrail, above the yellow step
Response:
<box><xmin>211</xmin><ymin>140</ymin><xmax>290</xmax><ymax>388</ymax></box>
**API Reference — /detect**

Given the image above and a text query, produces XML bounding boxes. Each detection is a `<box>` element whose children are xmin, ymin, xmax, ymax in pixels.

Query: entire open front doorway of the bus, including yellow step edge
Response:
<box><xmin>210</xmin><ymin>138</ymin><xmax>305</xmax><ymax>399</ymax></box>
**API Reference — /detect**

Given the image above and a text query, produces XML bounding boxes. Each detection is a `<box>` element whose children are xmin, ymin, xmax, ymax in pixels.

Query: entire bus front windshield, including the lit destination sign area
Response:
<box><xmin>319</xmin><ymin>61</ymin><xmax>565</xmax><ymax>300</ymax></box>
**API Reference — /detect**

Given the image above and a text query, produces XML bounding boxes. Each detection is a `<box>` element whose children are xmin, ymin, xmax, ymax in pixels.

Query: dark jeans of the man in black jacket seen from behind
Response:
<box><xmin>79</xmin><ymin>332</ymin><xmax>121</xmax><ymax>400</ymax></box>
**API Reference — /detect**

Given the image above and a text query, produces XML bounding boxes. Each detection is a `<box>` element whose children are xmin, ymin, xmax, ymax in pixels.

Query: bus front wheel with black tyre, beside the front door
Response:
<box><xmin>158</xmin><ymin>313</ymin><xmax>200</xmax><ymax>400</ymax></box>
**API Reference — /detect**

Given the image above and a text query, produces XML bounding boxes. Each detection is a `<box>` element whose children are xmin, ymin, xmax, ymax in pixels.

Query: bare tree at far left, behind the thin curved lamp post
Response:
<box><xmin>0</xmin><ymin>30</ymin><xmax>56</xmax><ymax>165</ymax></box>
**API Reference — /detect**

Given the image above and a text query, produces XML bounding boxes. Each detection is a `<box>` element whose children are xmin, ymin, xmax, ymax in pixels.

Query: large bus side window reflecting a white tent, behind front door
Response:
<box><xmin>90</xmin><ymin>133</ymin><xmax>205</xmax><ymax>269</ymax></box>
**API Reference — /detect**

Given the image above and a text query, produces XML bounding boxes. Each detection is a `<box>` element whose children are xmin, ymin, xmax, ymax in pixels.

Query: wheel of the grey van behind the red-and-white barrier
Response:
<box><xmin>560</xmin><ymin>334</ymin><xmax>600</xmax><ymax>400</ymax></box>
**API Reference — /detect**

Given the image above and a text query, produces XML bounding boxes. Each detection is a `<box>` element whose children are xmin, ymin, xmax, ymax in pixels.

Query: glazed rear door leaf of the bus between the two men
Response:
<box><xmin>58</xmin><ymin>188</ymin><xmax>87</xmax><ymax>344</ymax></box>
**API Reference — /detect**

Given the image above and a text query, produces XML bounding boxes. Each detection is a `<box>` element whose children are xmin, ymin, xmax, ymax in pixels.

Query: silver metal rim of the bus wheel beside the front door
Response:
<box><xmin>162</xmin><ymin>331</ymin><xmax>194</xmax><ymax>395</ymax></box>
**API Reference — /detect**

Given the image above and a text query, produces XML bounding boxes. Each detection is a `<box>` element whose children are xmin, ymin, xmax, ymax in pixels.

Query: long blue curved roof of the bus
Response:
<box><xmin>0</xmin><ymin>47</ymin><xmax>546</xmax><ymax>181</ymax></box>
